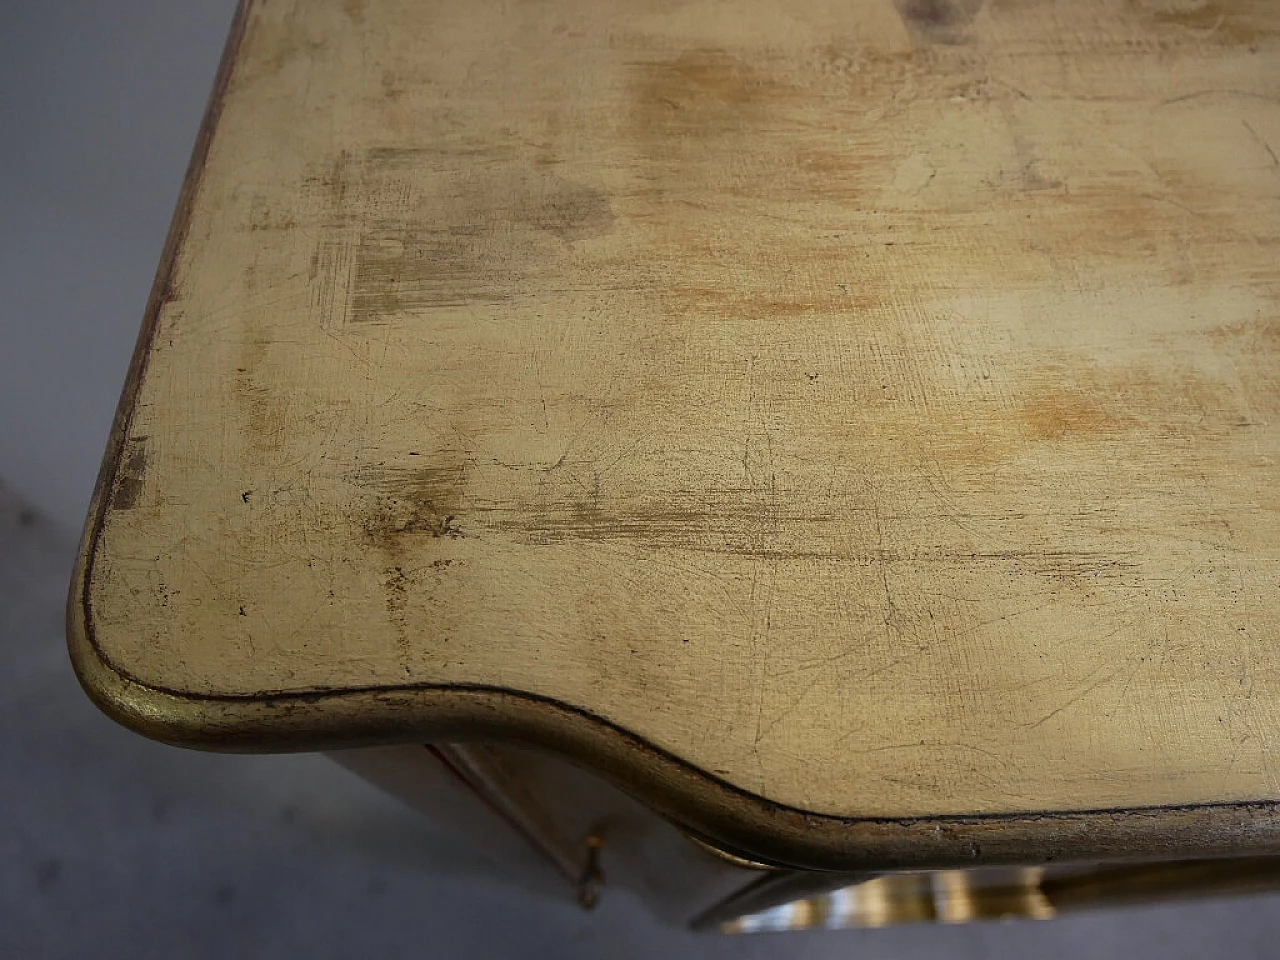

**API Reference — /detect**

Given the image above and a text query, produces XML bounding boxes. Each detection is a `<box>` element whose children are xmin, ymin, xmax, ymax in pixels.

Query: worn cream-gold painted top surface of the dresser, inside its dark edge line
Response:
<box><xmin>90</xmin><ymin>0</ymin><xmax>1280</xmax><ymax>817</ymax></box>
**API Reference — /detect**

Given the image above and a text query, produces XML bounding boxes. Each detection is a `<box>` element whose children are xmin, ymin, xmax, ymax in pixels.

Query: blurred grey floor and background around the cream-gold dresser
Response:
<box><xmin>0</xmin><ymin>0</ymin><xmax>1280</xmax><ymax>960</ymax></box>
